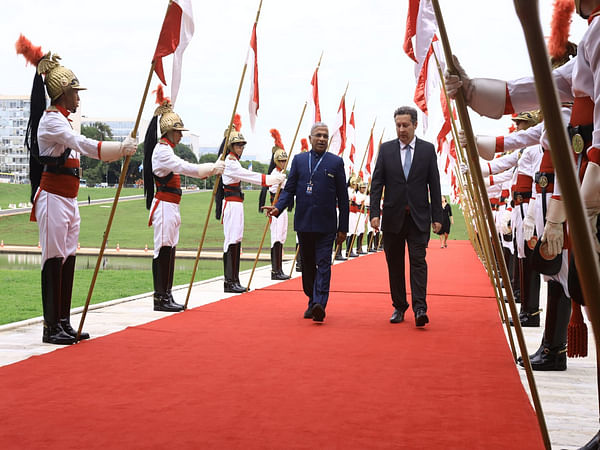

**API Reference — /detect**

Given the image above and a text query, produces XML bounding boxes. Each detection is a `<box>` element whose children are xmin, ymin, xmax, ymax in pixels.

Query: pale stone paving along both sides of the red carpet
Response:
<box><xmin>0</xmin><ymin>255</ymin><xmax>599</xmax><ymax>449</ymax></box>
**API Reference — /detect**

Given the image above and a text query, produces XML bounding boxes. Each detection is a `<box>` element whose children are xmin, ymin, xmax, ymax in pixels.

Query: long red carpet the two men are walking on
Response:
<box><xmin>0</xmin><ymin>241</ymin><xmax>543</xmax><ymax>449</ymax></box>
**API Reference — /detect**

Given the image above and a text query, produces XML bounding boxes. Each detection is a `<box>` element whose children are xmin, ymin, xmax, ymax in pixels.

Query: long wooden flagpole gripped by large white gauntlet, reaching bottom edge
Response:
<box><xmin>432</xmin><ymin>0</ymin><xmax>552</xmax><ymax>449</ymax></box>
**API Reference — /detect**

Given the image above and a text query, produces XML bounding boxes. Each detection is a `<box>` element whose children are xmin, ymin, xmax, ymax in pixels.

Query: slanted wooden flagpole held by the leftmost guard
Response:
<box><xmin>75</xmin><ymin>2</ymin><xmax>177</xmax><ymax>342</ymax></box>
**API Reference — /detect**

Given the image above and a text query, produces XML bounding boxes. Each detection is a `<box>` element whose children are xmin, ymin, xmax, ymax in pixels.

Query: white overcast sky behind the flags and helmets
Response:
<box><xmin>0</xmin><ymin>0</ymin><xmax>587</xmax><ymax>167</ymax></box>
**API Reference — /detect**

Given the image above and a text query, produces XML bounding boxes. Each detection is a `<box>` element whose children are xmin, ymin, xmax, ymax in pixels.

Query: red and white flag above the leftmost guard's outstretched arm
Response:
<box><xmin>152</xmin><ymin>0</ymin><xmax>194</xmax><ymax>104</ymax></box>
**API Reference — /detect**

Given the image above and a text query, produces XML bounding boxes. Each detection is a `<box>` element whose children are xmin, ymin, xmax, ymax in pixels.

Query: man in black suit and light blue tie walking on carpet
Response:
<box><xmin>370</xmin><ymin>106</ymin><xmax>442</xmax><ymax>327</ymax></box>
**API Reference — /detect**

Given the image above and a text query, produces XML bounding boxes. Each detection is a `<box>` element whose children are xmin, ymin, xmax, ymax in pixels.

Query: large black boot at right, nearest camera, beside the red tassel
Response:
<box><xmin>531</xmin><ymin>280</ymin><xmax>571</xmax><ymax>371</ymax></box>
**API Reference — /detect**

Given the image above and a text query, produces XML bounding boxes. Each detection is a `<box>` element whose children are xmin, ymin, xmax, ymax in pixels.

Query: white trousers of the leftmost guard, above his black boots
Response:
<box><xmin>35</xmin><ymin>189</ymin><xmax>81</xmax><ymax>268</ymax></box>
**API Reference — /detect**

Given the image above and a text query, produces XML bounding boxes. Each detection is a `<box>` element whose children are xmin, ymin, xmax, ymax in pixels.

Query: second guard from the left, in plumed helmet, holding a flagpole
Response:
<box><xmin>144</xmin><ymin>85</ymin><xmax>225</xmax><ymax>312</ymax></box>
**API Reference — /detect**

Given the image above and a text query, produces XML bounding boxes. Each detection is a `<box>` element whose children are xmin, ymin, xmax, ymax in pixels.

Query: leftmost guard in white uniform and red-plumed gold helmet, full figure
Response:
<box><xmin>16</xmin><ymin>35</ymin><xmax>136</xmax><ymax>345</ymax></box>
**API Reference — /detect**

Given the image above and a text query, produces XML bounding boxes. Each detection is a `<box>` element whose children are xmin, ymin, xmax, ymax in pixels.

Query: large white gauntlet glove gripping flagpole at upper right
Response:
<box><xmin>444</xmin><ymin>56</ymin><xmax>506</xmax><ymax>119</ymax></box>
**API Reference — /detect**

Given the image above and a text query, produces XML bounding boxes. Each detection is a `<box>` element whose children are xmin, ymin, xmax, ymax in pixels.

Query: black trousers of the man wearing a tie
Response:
<box><xmin>383</xmin><ymin>211</ymin><xmax>429</xmax><ymax>313</ymax></box>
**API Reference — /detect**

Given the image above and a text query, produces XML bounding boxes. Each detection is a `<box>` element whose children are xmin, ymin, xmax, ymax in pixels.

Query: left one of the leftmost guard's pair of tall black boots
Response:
<box><xmin>42</xmin><ymin>258</ymin><xmax>75</xmax><ymax>345</ymax></box>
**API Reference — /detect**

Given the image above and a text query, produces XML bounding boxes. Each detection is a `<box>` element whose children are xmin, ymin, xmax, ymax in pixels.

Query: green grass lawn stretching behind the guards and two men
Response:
<box><xmin>0</xmin><ymin>184</ymin><xmax>468</xmax><ymax>324</ymax></box>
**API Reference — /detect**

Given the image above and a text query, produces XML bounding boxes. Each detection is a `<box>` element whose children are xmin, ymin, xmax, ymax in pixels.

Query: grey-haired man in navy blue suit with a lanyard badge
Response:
<box><xmin>264</xmin><ymin>122</ymin><xmax>349</xmax><ymax>322</ymax></box>
